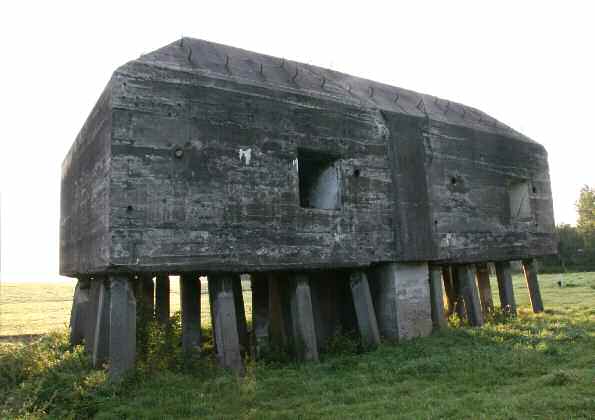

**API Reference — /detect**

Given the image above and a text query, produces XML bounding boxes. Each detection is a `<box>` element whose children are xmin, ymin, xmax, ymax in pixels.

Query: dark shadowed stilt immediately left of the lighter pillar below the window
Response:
<box><xmin>267</xmin><ymin>273</ymin><xmax>290</xmax><ymax>350</ymax></box>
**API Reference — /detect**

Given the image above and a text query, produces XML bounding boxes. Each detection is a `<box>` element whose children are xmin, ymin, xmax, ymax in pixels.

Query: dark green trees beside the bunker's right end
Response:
<box><xmin>541</xmin><ymin>185</ymin><xmax>595</xmax><ymax>272</ymax></box>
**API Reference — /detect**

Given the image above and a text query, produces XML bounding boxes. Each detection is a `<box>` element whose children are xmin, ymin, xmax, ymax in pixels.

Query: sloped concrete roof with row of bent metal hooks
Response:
<box><xmin>116</xmin><ymin>38</ymin><xmax>535</xmax><ymax>143</ymax></box>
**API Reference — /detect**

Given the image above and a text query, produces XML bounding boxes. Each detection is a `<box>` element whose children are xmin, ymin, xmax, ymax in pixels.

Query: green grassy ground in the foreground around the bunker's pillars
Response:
<box><xmin>0</xmin><ymin>273</ymin><xmax>595</xmax><ymax>419</ymax></box>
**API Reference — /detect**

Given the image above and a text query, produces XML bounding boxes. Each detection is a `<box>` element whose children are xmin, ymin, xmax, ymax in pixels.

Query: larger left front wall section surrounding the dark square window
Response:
<box><xmin>110</xmin><ymin>65</ymin><xmax>396</xmax><ymax>272</ymax></box>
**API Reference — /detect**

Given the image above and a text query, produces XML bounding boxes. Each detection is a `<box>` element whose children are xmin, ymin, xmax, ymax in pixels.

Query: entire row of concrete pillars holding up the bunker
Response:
<box><xmin>71</xmin><ymin>261</ymin><xmax>543</xmax><ymax>379</ymax></box>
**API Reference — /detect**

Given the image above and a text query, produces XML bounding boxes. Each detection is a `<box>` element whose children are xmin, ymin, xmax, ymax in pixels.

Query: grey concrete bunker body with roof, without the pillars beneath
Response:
<box><xmin>60</xmin><ymin>38</ymin><xmax>556</xmax><ymax>276</ymax></box>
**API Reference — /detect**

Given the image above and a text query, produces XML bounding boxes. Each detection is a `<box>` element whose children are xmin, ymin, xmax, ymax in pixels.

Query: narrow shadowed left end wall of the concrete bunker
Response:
<box><xmin>60</xmin><ymin>82</ymin><xmax>112</xmax><ymax>276</ymax></box>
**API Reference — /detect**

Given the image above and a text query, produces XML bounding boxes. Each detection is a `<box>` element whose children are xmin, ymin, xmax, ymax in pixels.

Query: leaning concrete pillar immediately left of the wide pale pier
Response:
<box><xmin>349</xmin><ymin>271</ymin><xmax>380</xmax><ymax>348</ymax></box>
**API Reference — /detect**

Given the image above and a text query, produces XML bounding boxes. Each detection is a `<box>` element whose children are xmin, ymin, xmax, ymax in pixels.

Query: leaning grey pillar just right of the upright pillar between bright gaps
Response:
<box><xmin>209</xmin><ymin>274</ymin><xmax>244</xmax><ymax>373</ymax></box>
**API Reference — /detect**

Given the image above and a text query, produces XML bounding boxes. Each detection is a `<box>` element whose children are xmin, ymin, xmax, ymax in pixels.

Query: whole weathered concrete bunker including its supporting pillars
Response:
<box><xmin>60</xmin><ymin>38</ymin><xmax>556</xmax><ymax>376</ymax></box>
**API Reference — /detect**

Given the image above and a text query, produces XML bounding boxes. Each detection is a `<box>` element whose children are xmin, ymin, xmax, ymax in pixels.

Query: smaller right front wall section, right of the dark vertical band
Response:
<box><xmin>425</xmin><ymin>119</ymin><xmax>557</xmax><ymax>262</ymax></box>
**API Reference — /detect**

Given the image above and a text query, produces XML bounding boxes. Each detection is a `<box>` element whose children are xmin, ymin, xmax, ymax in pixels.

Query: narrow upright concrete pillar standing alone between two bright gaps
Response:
<box><xmin>180</xmin><ymin>273</ymin><xmax>201</xmax><ymax>355</ymax></box>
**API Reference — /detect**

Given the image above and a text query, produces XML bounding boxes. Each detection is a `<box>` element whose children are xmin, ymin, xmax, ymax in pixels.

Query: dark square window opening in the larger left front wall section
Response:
<box><xmin>297</xmin><ymin>149</ymin><xmax>341</xmax><ymax>210</ymax></box>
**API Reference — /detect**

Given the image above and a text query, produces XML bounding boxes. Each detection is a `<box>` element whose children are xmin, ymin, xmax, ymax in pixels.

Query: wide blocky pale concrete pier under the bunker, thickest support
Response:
<box><xmin>370</xmin><ymin>263</ymin><xmax>432</xmax><ymax>340</ymax></box>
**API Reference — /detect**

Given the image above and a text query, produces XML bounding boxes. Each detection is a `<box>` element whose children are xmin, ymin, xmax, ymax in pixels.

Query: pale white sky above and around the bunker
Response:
<box><xmin>0</xmin><ymin>0</ymin><xmax>595</xmax><ymax>281</ymax></box>
